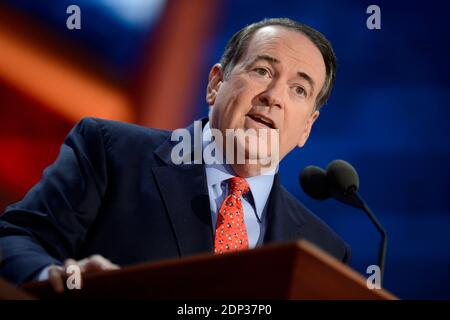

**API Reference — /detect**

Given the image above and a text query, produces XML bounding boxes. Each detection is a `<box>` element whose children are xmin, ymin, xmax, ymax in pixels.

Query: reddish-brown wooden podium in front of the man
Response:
<box><xmin>22</xmin><ymin>241</ymin><xmax>396</xmax><ymax>300</ymax></box>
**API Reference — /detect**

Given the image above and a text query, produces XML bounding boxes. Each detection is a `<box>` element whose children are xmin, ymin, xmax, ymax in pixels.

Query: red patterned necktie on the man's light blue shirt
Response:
<box><xmin>214</xmin><ymin>177</ymin><xmax>250</xmax><ymax>254</ymax></box>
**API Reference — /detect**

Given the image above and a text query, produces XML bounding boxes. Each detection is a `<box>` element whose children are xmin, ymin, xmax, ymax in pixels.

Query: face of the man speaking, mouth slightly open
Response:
<box><xmin>207</xmin><ymin>26</ymin><xmax>325</xmax><ymax>165</ymax></box>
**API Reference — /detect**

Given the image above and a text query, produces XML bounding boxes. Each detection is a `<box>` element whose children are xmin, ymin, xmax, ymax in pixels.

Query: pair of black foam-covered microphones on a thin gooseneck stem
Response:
<box><xmin>299</xmin><ymin>160</ymin><xmax>387</xmax><ymax>283</ymax></box>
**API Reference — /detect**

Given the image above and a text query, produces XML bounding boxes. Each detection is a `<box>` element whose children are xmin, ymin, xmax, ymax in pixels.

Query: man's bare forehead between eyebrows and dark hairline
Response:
<box><xmin>242</xmin><ymin>26</ymin><xmax>326</xmax><ymax>87</ymax></box>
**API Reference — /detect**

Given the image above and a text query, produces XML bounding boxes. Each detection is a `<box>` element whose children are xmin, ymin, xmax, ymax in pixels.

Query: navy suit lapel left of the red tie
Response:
<box><xmin>152</xmin><ymin>120</ymin><xmax>213</xmax><ymax>256</ymax></box>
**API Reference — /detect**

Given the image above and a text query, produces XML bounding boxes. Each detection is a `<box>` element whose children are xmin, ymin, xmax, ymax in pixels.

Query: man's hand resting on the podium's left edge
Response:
<box><xmin>48</xmin><ymin>254</ymin><xmax>120</xmax><ymax>293</ymax></box>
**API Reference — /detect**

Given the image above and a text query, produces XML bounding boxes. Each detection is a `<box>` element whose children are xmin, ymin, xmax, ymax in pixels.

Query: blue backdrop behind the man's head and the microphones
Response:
<box><xmin>191</xmin><ymin>0</ymin><xmax>450</xmax><ymax>299</ymax></box>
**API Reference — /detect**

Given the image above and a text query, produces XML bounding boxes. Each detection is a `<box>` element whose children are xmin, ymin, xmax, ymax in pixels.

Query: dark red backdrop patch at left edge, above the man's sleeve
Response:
<box><xmin>0</xmin><ymin>84</ymin><xmax>73</xmax><ymax>212</ymax></box>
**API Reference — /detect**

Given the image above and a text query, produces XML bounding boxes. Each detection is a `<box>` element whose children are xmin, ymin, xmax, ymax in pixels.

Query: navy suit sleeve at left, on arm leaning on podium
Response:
<box><xmin>0</xmin><ymin>118</ymin><xmax>107</xmax><ymax>284</ymax></box>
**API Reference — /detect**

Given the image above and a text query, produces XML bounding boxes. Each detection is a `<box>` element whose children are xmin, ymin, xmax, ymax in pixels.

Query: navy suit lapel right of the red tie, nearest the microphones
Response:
<box><xmin>264</xmin><ymin>174</ymin><xmax>306</xmax><ymax>243</ymax></box>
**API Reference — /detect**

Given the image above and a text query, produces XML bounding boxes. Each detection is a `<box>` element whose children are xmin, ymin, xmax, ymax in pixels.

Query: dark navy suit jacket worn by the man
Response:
<box><xmin>0</xmin><ymin>118</ymin><xmax>350</xmax><ymax>284</ymax></box>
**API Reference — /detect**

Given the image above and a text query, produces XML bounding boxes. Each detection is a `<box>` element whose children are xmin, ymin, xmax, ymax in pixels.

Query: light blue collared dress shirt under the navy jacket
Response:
<box><xmin>202</xmin><ymin>123</ymin><xmax>276</xmax><ymax>248</ymax></box>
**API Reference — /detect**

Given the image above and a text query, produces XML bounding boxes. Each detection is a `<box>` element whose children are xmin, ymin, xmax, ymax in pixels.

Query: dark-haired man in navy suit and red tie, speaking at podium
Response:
<box><xmin>0</xmin><ymin>19</ymin><xmax>349</xmax><ymax>291</ymax></box>
